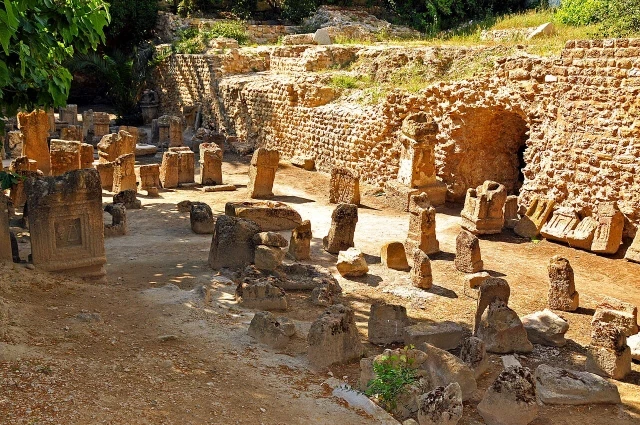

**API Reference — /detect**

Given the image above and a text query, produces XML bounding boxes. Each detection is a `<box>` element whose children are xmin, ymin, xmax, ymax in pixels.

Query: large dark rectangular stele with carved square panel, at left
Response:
<box><xmin>25</xmin><ymin>169</ymin><xmax>107</xmax><ymax>279</ymax></box>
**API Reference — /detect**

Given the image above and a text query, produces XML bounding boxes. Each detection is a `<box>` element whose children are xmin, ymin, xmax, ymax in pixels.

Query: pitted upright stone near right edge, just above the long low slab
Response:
<box><xmin>586</xmin><ymin>321</ymin><xmax>631</xmax><ymax>380</ymax></box>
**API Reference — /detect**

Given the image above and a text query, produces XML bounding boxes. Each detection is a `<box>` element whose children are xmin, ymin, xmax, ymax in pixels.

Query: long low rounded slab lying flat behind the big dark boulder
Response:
<box><xmin>224</xmin><ymin>201</ymin><xmax>302</xmax><ymax>232</ymax></box>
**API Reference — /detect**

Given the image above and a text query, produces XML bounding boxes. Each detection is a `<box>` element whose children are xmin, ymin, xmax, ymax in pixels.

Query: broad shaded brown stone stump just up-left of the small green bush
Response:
<box><xmin>308</xmin><ymin>304</ymin><xmax>364</xmax><ymax>368</ymax></box>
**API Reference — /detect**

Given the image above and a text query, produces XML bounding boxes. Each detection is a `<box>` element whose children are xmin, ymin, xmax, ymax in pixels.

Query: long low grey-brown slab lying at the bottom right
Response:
<box><xmin>535</xmin><ymin>364</ymin><xmax>620</xmax><ymax>405</ymax></box>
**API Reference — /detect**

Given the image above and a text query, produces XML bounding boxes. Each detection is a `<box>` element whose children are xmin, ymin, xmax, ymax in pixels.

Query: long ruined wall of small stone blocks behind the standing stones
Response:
<box><xmin>152</xmin><ymin>39</ymin><xmax>640</xmax><ymax>234</ymax></box>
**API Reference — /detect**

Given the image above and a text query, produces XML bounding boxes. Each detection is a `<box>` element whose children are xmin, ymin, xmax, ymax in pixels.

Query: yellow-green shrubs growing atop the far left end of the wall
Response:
<box><xmin>173</xmin><ymin>21</ymin><xmax>249</xmax><ymax>54</ymax></box>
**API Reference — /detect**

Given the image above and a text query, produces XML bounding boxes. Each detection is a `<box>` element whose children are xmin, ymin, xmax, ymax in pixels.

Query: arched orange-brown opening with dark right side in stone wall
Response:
<box><xmin>441</xmin><ymin>108</ymin><xmax>529</xmax><ymax>201</ymax></box>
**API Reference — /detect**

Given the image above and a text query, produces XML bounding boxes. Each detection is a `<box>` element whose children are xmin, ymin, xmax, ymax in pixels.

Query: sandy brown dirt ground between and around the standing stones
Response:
<box><xmin>0</xmin><ymin>151</ymin><xmax>640</xmax><ymax>425</ymax></box>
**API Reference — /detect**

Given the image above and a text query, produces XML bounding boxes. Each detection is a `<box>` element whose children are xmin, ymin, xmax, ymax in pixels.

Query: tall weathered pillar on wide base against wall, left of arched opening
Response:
<box><xmin>385</xmin><ymin>112</ymin><xmax>447</xmax><ymax>211</ymax></box>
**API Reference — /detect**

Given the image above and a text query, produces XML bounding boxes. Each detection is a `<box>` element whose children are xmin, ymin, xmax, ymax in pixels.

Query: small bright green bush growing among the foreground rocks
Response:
<box><xmin>365</xmin><ymin>354</ymin><xmax>418</xmax><ymax>411</ymax></box>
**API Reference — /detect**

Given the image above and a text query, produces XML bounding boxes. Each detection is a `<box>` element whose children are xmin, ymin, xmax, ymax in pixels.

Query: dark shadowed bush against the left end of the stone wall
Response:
<box><xmin>68</xmin><ymin>46</ymin><xmax>156</xmax><ymax>124</ymax></box>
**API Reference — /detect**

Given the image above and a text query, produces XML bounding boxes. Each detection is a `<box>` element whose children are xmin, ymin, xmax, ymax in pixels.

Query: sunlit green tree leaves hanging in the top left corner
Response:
<box><xmin>0</xmin><ymin>0</ymin><xmax>110</xmax><ymax>115</ymax></box>
